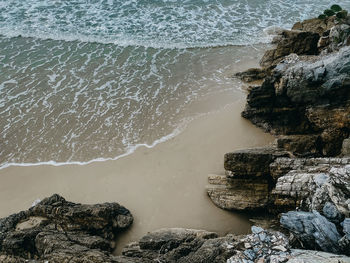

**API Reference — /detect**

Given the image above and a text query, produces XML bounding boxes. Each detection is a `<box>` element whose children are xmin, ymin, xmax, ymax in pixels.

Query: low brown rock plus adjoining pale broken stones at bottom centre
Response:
<box><xmin>123</xmin><ymin>226</ymin><xmax>290</xmax><ymax>263</ymax></box>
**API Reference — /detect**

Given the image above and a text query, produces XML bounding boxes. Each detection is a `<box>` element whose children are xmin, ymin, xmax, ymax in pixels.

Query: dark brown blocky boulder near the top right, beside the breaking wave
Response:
<box><xmin>260</xmin><ymin>30</ymin><xmax>320</xmax><ymax>67</ymax></box>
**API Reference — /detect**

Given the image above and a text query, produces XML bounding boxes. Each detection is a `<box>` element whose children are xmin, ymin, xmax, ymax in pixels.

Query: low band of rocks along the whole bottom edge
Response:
<box><xmin>0</xmin><ymin>195</ymin><xmax>350</xmax><ymax>263</ymax></box>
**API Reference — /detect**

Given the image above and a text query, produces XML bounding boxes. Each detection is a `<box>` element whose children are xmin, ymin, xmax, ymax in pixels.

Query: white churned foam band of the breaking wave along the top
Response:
<box><xmin>0</xmin><ymin>0</ymin><xmax>350</xmax><ymax>48</ymax></box>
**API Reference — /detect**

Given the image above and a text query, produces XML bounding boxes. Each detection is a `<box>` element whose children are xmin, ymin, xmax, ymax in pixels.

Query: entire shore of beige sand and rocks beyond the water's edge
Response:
<box><xmin>0</xmin><ymin>6</ymin><xmax>350</xmax><ymax>263</ymax></box>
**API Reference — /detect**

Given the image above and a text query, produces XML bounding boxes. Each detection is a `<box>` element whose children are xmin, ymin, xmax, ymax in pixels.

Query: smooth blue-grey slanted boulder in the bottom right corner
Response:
<box><xmin>280</xmin><ymin>211</ymin><xmax>342</xmax><ymax>253</ymax></box>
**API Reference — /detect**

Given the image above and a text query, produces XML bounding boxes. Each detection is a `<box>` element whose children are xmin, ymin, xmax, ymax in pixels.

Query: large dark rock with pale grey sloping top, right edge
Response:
<box><xmin>242</xmin><ymin>47</ymin><xmax>350</xmax><ymax>156</ymax></box>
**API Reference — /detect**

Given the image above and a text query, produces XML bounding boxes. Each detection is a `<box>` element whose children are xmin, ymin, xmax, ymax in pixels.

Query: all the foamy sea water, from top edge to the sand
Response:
<box><xmin>0</xmin><ymin>0</ymin><xmax>350</xmax><ymax>168</ymax></box>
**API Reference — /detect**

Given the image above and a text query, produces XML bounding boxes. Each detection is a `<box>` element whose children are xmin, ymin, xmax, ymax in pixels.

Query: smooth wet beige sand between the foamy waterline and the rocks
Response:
<box><xmin>0</xmin><ymin>99</ymin><xmax>273</xmax><ymax>254</ymax></box>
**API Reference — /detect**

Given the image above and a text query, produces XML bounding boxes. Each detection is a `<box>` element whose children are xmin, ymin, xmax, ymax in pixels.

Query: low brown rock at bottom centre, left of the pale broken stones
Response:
<box><xmin>122</xmin><ymin>228</ymin><xmax>238</xmax><ymax>263</ymax></box>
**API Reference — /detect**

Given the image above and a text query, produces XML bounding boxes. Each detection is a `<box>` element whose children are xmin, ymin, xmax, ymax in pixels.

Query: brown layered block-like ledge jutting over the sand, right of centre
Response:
<box><xmin>207</xmin><ymin>147</ymin><xmax>290</xmax><ymax>210</ymax></box>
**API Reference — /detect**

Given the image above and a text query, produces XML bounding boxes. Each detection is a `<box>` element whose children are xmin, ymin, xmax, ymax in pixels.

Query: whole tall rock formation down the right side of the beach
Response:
<box><xmin>207</xmin><ymin>12</ymin><xmax>350</xmax><ymax>255</ymax></box>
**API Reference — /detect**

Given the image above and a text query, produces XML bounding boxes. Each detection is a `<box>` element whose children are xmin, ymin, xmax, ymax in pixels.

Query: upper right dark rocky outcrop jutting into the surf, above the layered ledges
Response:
<box><xmin>237</xmin><ymin>16</ymin><xmax>350</xmax><ymax>157</ymax></box>
